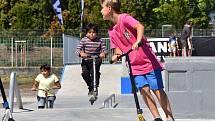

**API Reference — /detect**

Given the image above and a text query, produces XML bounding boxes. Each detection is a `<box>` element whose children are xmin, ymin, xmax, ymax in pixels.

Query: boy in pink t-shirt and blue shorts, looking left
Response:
<box><xmin>101</xmin><ymin>0</ymin><xmax>174</xmax><ymax>121</ymax></box>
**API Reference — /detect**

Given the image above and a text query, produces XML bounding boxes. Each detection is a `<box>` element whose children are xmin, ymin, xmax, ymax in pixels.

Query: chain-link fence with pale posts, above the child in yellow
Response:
<box><xmin>0</xmin><ymin>36</ymin><xmax>63</xmax><ymax>67</ymax></box>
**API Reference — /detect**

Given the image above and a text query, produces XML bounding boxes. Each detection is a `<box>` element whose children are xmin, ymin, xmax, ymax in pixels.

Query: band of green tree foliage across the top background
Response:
<box><xmin>0</xmin><ymin>0</ymin><xmax>215</xmax><ymax>29</ymax></box>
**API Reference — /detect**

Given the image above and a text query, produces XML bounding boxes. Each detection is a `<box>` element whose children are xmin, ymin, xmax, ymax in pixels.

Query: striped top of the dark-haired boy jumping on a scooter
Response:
<box><xmin>76</xmin><ymin>37</ymin><xmax>107</xmax><ymax>56</ymax></box>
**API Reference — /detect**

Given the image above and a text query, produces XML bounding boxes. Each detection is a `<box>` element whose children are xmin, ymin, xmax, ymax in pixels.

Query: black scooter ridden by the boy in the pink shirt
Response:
<box><xmin>110</xmin><ymin>42</ymin><xmax>146</xmax><ymax>121</ymax></box>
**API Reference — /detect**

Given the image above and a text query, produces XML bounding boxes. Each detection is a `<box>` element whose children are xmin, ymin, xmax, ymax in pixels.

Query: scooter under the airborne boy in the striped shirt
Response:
<box><xmin>89</xmin><ymin>55</ymin><xmax>98</xmax><ymax>105</ymax></box>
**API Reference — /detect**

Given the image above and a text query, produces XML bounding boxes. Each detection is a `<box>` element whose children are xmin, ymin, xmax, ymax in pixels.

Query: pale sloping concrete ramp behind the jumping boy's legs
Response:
<box><xmin>57</xmin><ymin>64</ymin><xmax>122</xmax><ymax>97</ymax></box>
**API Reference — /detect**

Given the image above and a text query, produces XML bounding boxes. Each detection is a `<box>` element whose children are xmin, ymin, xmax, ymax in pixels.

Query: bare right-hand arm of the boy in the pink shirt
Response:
<box><xmin>132</xmin><ymin>23</ymin><xmax>144</xmax><ymax>49</ymax></box>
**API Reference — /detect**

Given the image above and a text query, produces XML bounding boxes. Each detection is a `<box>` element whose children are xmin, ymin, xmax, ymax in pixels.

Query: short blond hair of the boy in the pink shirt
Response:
<box><xmin>100</xmin><ymin>0</ymin><xmax>121</xmax><ymax>13</ymax></box>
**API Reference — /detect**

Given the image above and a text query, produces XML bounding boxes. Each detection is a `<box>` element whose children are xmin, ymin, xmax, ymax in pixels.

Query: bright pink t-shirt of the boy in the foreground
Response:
<box><xmin>108</xmin><ymin>13</ymin><xmax>163</xmax><ymax>75</ymax></box>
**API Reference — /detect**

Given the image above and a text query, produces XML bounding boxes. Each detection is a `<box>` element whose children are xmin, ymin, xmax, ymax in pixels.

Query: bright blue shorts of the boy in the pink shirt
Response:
<box><xmin>134</xmin><ymin>69</ymin><xmax>164</xmax><ymax>90</ymax></box>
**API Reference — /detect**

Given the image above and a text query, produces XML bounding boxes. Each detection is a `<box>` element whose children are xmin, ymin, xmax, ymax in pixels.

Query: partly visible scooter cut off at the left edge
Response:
<box><xmin>0</xmin><ymin>78</ymin><xmax>15</xmax><ymax>121</ymax></box>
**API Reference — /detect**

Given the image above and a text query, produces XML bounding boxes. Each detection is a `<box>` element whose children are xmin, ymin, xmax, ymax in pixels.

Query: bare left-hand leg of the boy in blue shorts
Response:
<box><xmin>141</xmin><ymin>87</ymin><xmax>160</xmax><ymax>118</ymax></box>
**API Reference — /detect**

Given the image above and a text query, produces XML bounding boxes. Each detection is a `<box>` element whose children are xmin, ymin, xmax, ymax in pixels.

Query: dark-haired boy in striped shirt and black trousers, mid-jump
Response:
<box><xmin>76</xmin><ymin>23</ymin><xmax>107</xmax><ymax>99</ymax></box>
